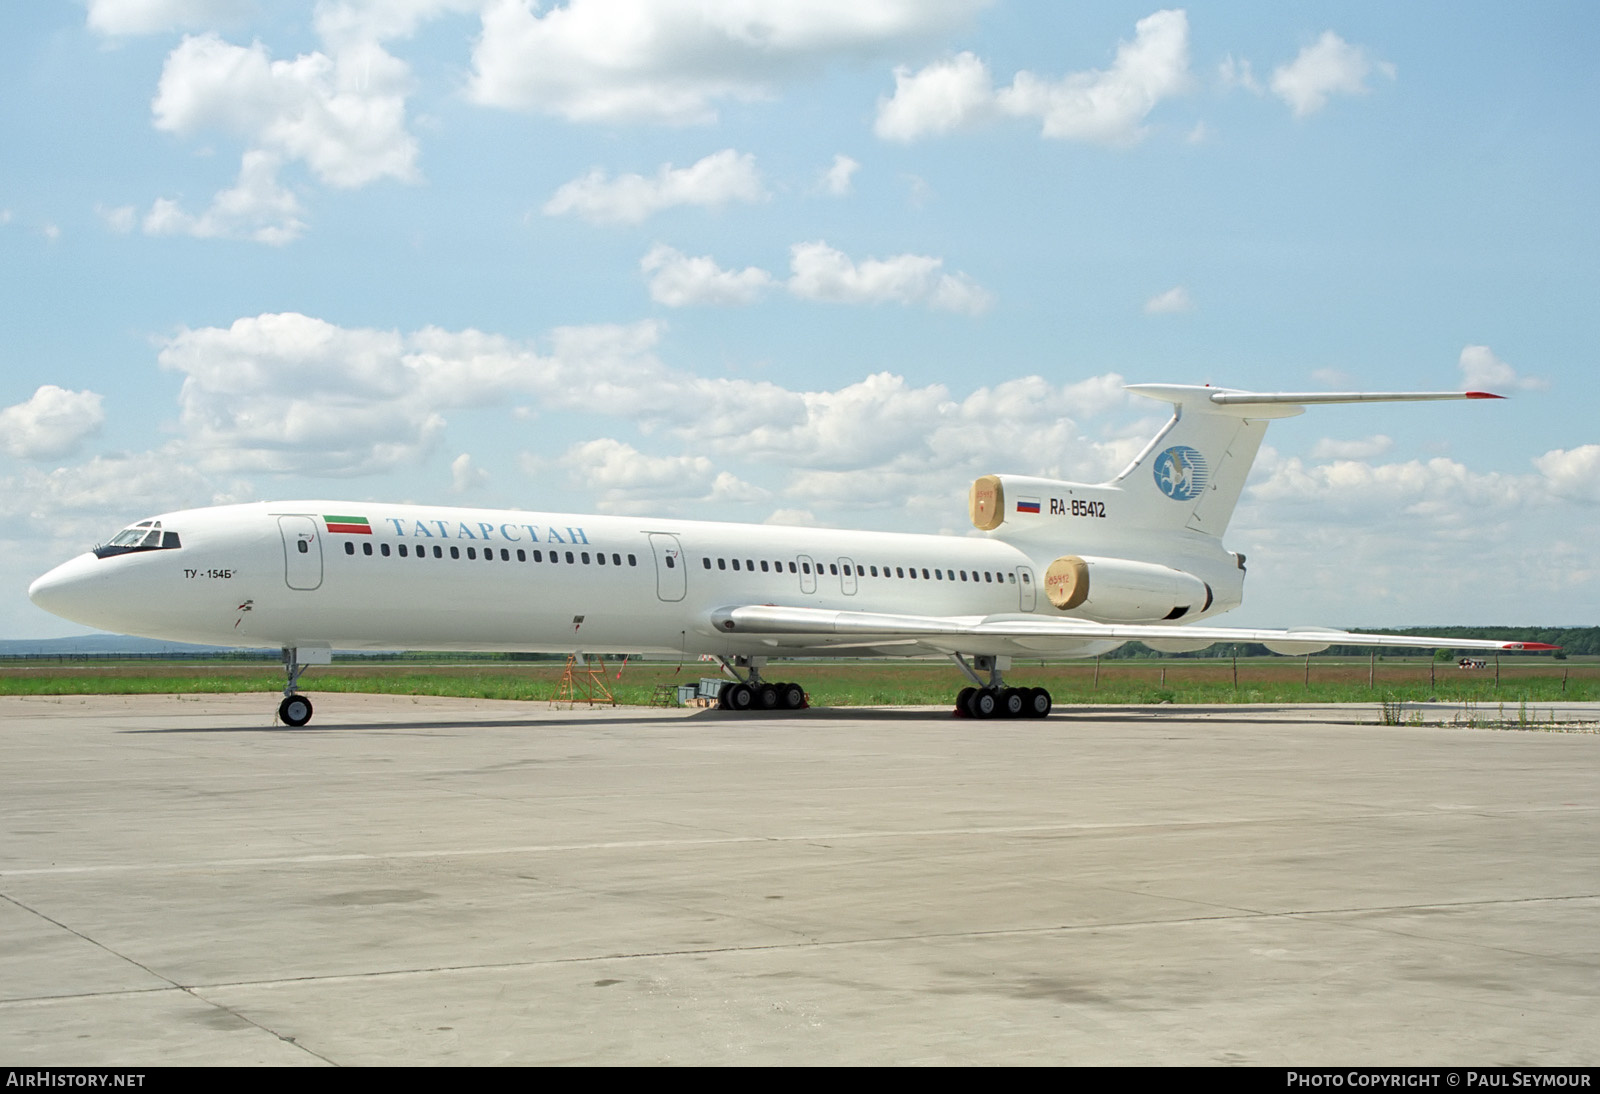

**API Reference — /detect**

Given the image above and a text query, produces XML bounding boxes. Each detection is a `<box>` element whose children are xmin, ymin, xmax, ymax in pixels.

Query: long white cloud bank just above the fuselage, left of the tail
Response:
<box><xmin>147</xmin><ymin>313</ymin><xmax>1146</xmax><ymax>520</ymax></box>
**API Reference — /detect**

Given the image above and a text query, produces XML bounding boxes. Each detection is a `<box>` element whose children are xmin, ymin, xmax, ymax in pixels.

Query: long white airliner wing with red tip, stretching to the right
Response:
<box><xmin>710</xmin><ymin>605</ymin><xmax>1560</xmax><ymax>654</ymax></box>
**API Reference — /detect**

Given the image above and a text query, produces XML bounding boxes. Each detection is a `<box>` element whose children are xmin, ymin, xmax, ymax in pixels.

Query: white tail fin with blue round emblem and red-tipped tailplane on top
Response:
<box><xmin>1106</xmin><ymin>384</ymin><xmax>1501</xmax><ymax>537</ymax></box>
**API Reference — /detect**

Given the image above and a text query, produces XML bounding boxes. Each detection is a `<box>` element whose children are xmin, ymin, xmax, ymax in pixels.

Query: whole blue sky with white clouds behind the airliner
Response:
<box><xmin>0</xmin><ymin>0</ymin><xmax>1600</xmax><ymax>637</ymax></box>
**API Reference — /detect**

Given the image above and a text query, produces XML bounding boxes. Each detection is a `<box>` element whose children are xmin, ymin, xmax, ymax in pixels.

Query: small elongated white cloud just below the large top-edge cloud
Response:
<box><xmin>544</xmin><ymin>149</ymin><xmax>768</xmax><ymax>224</ymax></box>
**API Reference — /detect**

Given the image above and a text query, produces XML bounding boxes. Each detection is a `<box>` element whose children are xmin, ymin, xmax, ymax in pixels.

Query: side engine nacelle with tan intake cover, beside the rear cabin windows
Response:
<box><xmin>1045</xmin><ymin>555</ymin><xmax>1211</xmax><ymax>622</ymax></box>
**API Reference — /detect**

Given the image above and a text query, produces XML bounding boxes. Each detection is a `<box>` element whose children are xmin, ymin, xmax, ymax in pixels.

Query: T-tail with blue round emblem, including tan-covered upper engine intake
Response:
<box><xmin>968</xmin><ymin>384</ymin><xmax>1501</xmax><ymax>541</ymax></box>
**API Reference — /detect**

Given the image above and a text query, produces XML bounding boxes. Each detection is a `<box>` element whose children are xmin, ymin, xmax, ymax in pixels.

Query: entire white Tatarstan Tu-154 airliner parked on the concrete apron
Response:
<box><xmin>29</xmin><ymin>384</ymin><xmax>1555</xmax><ymax>726</ymax></box>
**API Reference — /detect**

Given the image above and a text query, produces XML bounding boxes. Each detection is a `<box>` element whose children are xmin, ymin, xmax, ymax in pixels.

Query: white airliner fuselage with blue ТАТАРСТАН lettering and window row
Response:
<box><xmin>30</xmin><ymin>501</ymin><xmax>1243</xmax><ymax>657</ymax></box>
